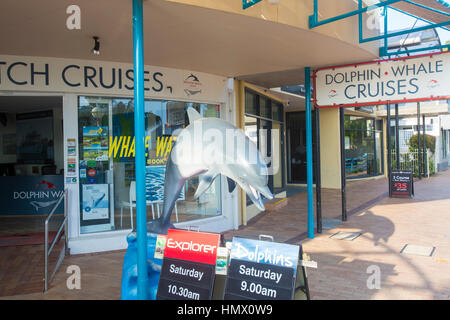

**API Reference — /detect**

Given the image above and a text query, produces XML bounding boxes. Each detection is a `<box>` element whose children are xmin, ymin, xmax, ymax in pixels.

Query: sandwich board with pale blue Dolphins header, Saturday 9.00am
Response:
<box><xmin>224</xmin><ymin>237</ymin><xmax>299</xmax><ymax>300</ymax></box>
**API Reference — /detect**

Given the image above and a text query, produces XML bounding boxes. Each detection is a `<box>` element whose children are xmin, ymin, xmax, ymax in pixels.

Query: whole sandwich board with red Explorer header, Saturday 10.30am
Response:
<box><xmin>156</xmin><ymin>229</ymin><xmax>220</xmax><ymax>300</ymax></box>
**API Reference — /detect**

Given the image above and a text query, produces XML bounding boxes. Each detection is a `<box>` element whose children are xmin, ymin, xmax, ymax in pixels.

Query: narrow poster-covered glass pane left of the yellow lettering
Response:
<box><xmin>79</xmin><ymin>97</ymin><xmax>115</xmax><ymax>234</ymax></box>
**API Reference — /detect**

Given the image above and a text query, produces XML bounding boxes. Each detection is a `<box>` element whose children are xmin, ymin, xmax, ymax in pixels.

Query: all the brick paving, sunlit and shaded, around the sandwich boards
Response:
<box><xmin>1</xmin><ymin>170</ymin><xmax>450</xmax><ymax>300</ymax></box>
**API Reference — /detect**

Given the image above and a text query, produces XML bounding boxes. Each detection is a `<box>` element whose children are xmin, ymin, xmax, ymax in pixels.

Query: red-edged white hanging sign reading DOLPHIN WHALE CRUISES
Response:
<box><xmin>314</xmin><ymin>52</ymin><xmax>450</xmax><ymax>108</ymax></box>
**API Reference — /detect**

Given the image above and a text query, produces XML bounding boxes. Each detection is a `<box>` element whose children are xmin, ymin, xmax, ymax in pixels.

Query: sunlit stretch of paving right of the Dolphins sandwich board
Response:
<box><xmin>301</xmin><ymin>170</ymin><xmax>450</xmax><ymax>300</ymax></box>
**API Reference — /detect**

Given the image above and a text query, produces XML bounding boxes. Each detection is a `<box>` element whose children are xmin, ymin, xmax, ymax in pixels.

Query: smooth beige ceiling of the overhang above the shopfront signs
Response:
<box><xmin>0</xmin><ymin>0</ymin><xmax>376</xmax><ymax>87</ymax></box>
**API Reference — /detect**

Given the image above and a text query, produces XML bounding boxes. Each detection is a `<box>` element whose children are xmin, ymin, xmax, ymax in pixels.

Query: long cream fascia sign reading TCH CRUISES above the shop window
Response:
<box><xmin>0</xmin><ymin>55</ymin><xmax>227</xmax><ymax>102</ymax></box>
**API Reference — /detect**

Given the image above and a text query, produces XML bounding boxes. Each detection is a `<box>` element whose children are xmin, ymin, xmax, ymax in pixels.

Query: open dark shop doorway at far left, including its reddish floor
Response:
<box><xmin>0</xmin><ymin>95</ymin><xmax>64</xmax><ymax>296</ymax></box>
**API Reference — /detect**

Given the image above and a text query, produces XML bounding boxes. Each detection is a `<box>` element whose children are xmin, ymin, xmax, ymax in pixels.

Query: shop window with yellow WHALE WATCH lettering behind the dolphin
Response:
<box><xmin>79</xmin><ymin>97</ymin><xmax>221</xmax><ymax>233</ymax></box>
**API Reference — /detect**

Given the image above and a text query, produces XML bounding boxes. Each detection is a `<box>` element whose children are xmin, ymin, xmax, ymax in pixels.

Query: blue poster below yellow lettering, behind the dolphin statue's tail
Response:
<box><xmin>145</xmin><ymin>166</ymin><xmax>185</xmax><ymax>203</ymax></box>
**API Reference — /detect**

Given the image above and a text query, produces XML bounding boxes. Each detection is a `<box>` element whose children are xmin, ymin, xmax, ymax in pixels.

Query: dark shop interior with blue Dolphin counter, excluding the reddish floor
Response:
<box><xmin>0</xmin><ymin>95</ymin><xmax>64</xmax><ymax>239</ymax></box>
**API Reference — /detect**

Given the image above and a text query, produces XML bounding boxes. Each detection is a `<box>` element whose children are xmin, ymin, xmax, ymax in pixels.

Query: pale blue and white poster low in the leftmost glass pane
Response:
<box><xmin>82</xmin><ymin>184</ymin><xmax>109</xmax><ymax>221</ymax></box>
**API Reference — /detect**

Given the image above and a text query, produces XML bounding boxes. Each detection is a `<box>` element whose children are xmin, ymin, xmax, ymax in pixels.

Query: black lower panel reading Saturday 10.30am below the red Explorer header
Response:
<box><xmin>156</xmin><ymin>258</ymin><xmax>215</xmax><ymax>300</ymax></box>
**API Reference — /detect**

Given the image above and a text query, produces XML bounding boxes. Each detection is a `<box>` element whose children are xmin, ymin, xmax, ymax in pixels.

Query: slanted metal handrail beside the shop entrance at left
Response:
<box><xmin>44</xmin><ymin>189</ymin><xmax>69</xmax><ymax>292</ymax></box>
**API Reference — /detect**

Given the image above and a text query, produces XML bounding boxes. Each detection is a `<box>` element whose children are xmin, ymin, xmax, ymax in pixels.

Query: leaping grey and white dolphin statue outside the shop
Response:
<box><xmin>147</xmin><ymin>107</ymin><xmax>273</xmax><ymax>234</ymax></box>
